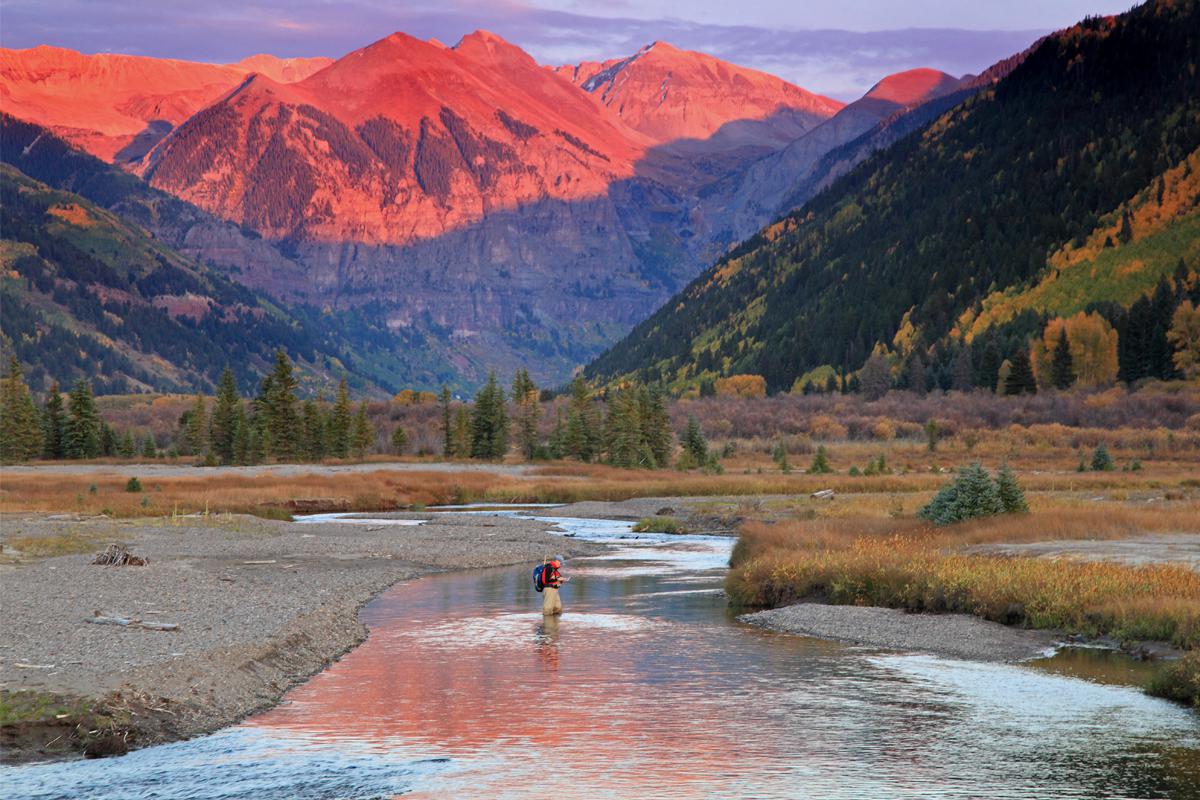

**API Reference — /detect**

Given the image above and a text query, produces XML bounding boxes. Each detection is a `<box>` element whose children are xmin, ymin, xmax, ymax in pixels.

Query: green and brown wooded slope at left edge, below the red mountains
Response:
<box><xmin>0</xmin><ymin>164</ymin><xmax>370</xmax><ymax>392</ymax></box>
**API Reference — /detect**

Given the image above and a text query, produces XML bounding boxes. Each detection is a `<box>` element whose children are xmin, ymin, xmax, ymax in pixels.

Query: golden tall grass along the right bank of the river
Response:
<box><xmin>727</xmin><ymin>504</ymin><xmax>1200</xmax><ymax>648</ymax></box>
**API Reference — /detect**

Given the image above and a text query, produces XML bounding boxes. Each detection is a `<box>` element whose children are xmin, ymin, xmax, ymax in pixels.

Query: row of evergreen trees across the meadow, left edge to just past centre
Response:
<box><xmin>0</xmin><ymin>350</ymin><xmax>700</xmax><ymax>469</ymax></box>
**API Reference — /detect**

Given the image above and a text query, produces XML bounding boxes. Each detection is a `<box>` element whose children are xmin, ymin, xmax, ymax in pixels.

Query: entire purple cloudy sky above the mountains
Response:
<box><xmin>0</xmin><ymin>0</ymin><xmax>1132</xmax><ymax>100</ymax></box>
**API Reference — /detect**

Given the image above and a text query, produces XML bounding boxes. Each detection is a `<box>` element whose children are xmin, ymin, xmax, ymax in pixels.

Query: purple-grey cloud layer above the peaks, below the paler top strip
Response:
<box><xmin>0</xmin><ymin>0</ymin><xmax>1045</xmax><ymax>100</ymax></box>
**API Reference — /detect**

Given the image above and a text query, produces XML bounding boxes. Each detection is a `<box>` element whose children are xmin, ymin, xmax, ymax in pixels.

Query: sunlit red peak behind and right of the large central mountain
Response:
<box><xmin>554</xmin><ymin>42</ymin><xmax>845</xmax><ymax>165</ymax></box>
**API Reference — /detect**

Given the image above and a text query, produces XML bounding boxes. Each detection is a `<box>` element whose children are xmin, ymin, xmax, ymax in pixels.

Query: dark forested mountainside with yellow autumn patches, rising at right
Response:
<box><xmin>587</xmin><ymin>0</ymin><xmax>1200</xmax><ymax>390</ymax></box>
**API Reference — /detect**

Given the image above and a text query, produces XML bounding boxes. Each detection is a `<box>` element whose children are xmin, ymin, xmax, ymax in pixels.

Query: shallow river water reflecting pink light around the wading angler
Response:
<box><xmin>7</xmin><ymin>510</ymin><xmax>1200</xmax><ymax>800</ymax></box>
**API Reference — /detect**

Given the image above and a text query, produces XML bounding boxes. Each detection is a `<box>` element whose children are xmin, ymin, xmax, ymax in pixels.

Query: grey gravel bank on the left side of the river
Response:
<box><xmin>0</xmin><ymin>513</ymin><xmax>596</xmax><ymax>763</ymax></box>
